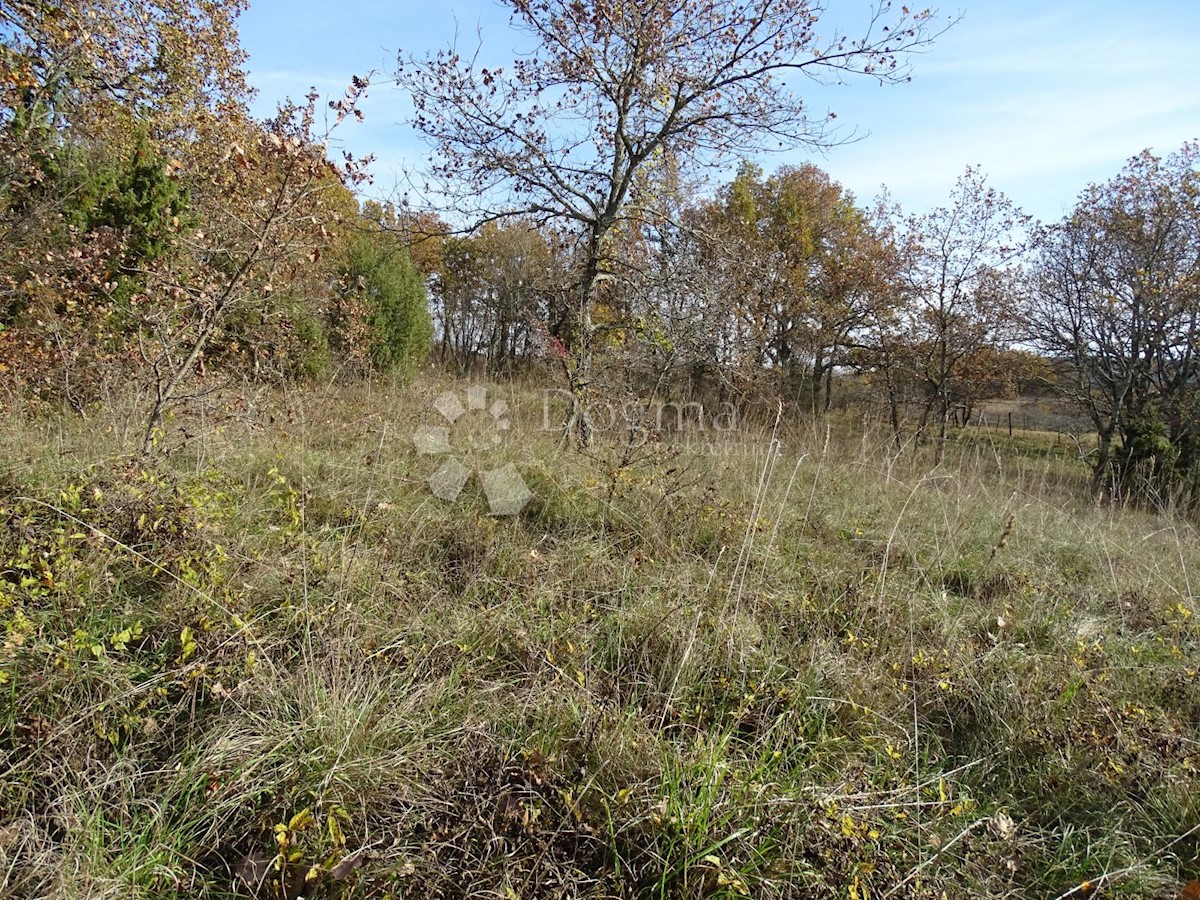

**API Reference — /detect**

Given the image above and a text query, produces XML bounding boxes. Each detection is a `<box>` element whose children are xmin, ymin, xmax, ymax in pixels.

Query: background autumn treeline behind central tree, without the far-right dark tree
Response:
<box><xmin>422</xmin><ymin>164</ymin><xmax>1049</xmax><ymax>448</ymax></box>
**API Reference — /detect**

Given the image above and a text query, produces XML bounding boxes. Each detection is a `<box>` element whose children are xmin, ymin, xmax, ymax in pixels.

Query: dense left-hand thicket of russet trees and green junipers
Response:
<box><xmin>0</xmin><ymin>0</ymin><xmax>431</xmax><ymax>450</ymax></box>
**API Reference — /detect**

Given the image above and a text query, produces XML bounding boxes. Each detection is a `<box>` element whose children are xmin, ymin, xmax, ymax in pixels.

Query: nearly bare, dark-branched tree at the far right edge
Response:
<box><xmin>1030</xmin><ymin>143</ymin><xmax>1200</xmax><ymax>502</ymax></box>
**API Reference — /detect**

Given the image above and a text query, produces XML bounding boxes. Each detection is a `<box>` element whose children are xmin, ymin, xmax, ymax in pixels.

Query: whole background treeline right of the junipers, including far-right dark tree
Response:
<box><xmin>414</xmin><ymin>153</ymin><xmax>1200</xmax><ymax>500</ymax></box>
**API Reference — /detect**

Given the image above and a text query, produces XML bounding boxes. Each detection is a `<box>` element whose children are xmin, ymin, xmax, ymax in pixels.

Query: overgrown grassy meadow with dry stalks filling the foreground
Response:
<box><xmin>0</xmin><ymin>379</ymin><xmax>1200</xmax><ymax>900</ymax></box>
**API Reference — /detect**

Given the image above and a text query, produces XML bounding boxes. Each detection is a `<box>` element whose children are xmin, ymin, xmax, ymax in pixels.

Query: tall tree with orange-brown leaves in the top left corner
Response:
<box><xmin>0</xmin><ymin>0</ymin><xmax>255</xmax><ymax>409</ymax></box>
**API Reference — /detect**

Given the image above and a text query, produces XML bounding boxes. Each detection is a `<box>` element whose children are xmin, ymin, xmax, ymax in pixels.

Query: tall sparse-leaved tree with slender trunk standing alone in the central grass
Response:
<box><xmin>396</xmin><ymin>0</ymin><xmax>950</xmax><ymax>444</ymax></box>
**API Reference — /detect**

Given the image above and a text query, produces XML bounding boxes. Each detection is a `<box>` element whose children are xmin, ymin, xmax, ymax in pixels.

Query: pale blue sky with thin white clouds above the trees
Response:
<box><xmin>241</xmin><ymin>0</ymin><xmax>1200</xmax><ymax>222</ymax></box>
